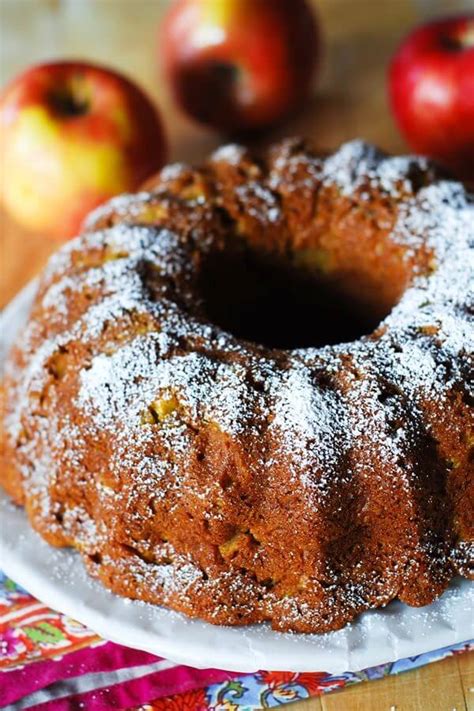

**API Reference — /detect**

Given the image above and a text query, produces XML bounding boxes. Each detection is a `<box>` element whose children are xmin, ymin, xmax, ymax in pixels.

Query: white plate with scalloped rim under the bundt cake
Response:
<box><xmin>0</xmin><ymin>284</ymin><xmax>474</xmax><ymax>673</ymax></box>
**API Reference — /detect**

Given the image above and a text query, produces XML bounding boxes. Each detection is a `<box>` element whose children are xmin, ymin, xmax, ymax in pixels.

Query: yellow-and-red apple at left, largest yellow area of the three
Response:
<box><xmin>0</xmin><ymin>62</ymin><xmax>166</xmax><ymax>238</ymax></box>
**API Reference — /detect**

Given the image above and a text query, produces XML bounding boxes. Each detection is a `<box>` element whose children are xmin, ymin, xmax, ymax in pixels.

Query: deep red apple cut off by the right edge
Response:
<box><xmin>389</xmin><ymin>15</ymin><xmax>474</xmax><ymax>178</ymax></box>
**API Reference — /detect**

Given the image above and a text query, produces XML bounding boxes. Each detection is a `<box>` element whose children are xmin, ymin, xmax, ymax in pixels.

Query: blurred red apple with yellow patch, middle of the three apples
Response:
<box><xmin>159</xmin><ymin>0</ymin><xmax>320</xmax><ymax>132</ymax></box>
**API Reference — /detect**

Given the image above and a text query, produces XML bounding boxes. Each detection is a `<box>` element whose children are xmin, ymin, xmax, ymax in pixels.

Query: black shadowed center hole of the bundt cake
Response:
<box><xmin>200</xmin><ymin>249</ymin><xmax>390</xmax><ymax>349</ymax></box>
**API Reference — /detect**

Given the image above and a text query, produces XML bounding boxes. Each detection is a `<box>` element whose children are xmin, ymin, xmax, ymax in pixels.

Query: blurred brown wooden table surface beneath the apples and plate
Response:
<box><xmin>0</xmin><ymin>0</ymin><xmax>474</xmax><ymax>711</ymax></box>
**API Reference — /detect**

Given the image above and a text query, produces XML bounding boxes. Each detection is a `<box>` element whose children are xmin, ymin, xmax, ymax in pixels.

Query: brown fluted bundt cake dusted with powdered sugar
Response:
<box><xmin>0</xmin><ymin>139</ymin><xmax>474</xmax><ymax>632</ymax></box>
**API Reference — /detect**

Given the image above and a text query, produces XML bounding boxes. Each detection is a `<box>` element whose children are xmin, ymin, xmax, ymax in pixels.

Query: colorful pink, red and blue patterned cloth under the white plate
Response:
<box><xmin>0</xmin><ymin>572</ymin><xmax>474</xmax><ymax>711</ymax></box>
